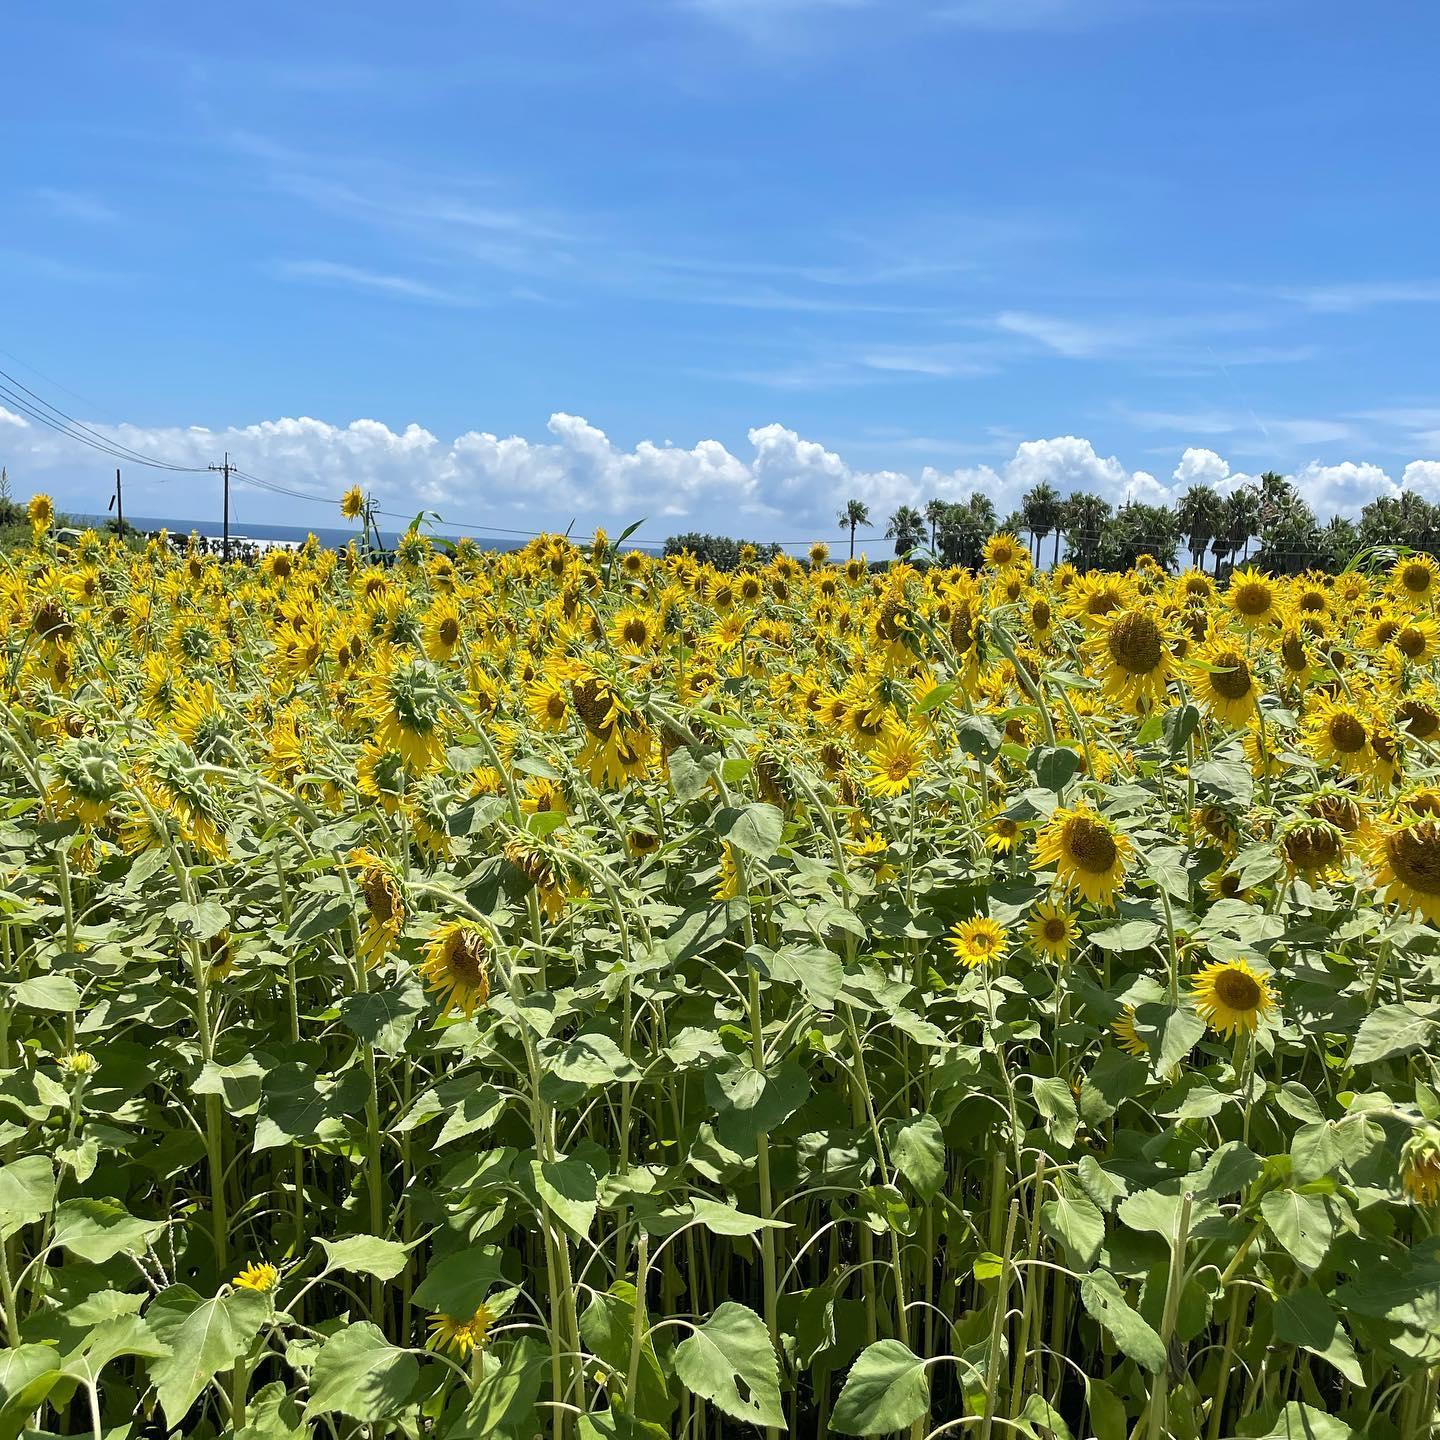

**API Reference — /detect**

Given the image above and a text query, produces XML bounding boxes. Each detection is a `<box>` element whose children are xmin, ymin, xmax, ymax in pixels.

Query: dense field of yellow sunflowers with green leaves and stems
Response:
<box><xmin>0</xmin><ymin>515</ymin><xmax>1440</xmax><ymax>1440</ymax></box>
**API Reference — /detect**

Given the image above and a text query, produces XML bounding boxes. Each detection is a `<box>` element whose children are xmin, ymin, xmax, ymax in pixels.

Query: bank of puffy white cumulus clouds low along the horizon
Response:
<box><xmin>11</xmin><ymin>408</ymin><xmax>1440</xmax><ymax>546</ymax></box>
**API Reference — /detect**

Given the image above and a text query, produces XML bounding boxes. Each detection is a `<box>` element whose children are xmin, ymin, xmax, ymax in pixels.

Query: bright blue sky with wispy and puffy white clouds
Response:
<box><xmin>0</xmin><ymin>0</ymin><xmax>1440</xmax><ymax>539</ymax></box>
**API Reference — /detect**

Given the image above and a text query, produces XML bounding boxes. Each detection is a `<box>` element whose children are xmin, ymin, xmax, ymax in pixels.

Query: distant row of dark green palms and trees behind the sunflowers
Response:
<box><xmin>665</xmin><ymin>471</ymin><xmax>1440</xmax><ymax>575</ymax></box>
